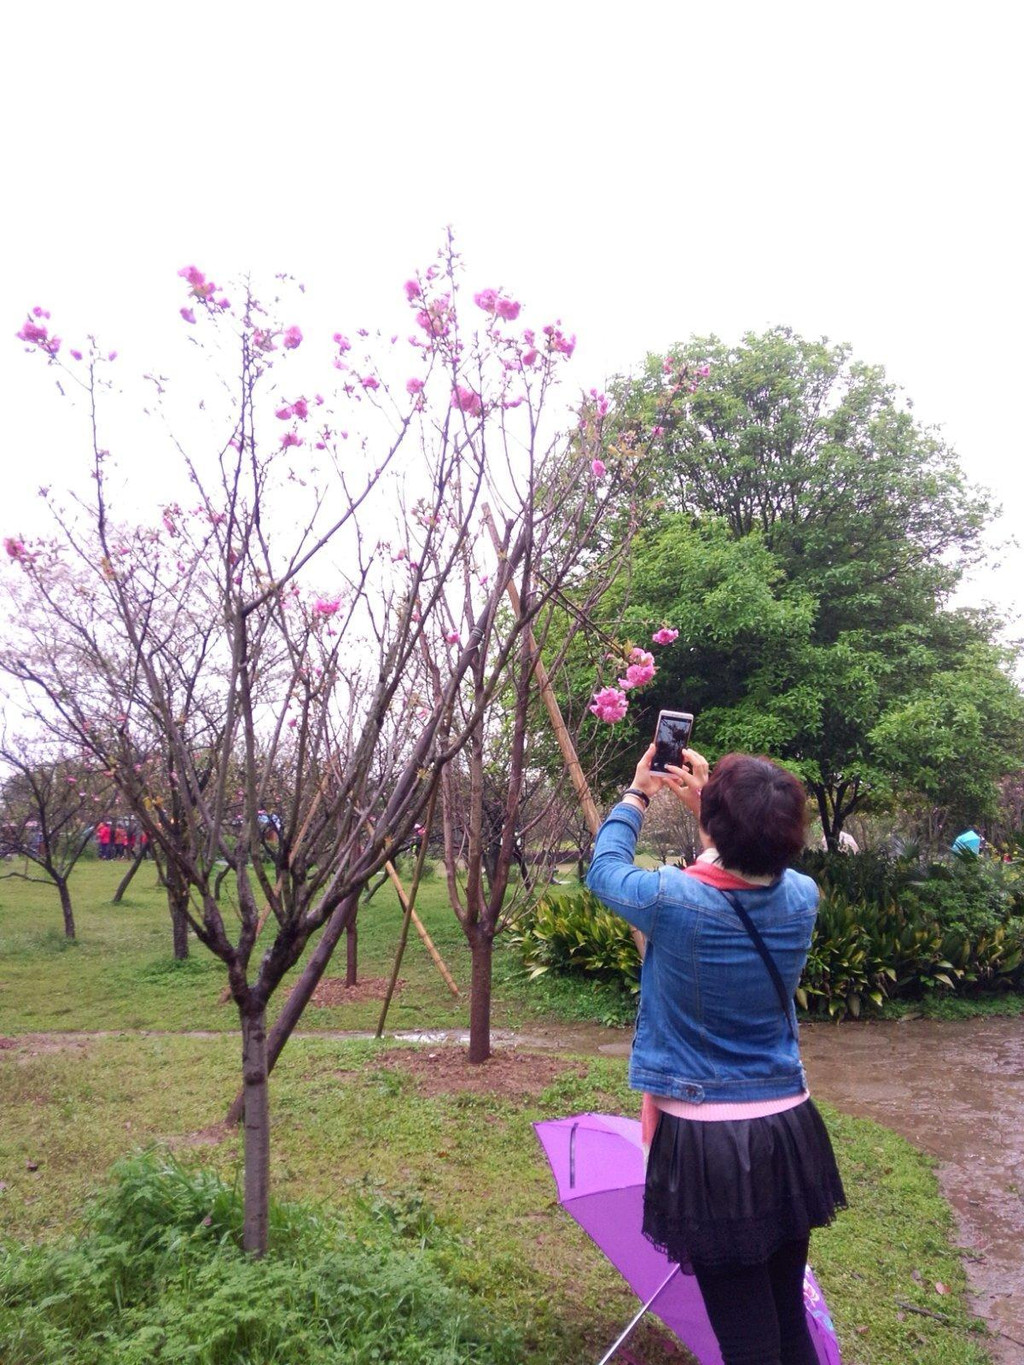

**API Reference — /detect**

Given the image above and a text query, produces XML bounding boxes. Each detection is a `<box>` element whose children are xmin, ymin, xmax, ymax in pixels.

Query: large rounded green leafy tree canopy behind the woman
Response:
<box><xmin>608</xmin><ymin>329</ymin><xmax>1024</xmax><ymax>842</ymax></box>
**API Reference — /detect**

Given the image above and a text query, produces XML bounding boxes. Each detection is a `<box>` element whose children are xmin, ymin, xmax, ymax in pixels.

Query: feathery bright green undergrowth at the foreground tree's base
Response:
<box><xmin>0</xmin><ymin>1155</ymin><xmax>523</xmax><ymax>1365</ymax></box>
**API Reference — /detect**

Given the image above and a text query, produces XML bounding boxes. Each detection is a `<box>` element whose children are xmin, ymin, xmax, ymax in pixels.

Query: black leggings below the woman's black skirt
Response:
<box><xmin>694</xmin><ymin>1238</ymin><xmax>818</xmax><ymax>1365</ymax></box>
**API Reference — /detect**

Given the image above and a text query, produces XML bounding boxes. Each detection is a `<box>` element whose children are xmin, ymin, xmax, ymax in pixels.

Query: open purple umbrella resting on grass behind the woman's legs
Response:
<box><xmin>534</xmin><ymin>1114</ymin><xmax>841</xmax><ymax>1365</ymax></box>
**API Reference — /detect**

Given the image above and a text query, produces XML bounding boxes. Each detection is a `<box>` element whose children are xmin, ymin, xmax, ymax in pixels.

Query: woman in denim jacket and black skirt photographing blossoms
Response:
<box><xmin>587</xmin><ymin>745</ymin><xmax>845</xmax><ymax>1365</ymax></box>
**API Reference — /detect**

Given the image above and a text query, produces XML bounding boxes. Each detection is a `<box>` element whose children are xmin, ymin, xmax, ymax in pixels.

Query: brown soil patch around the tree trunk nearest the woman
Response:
<box><xmin>374</xmin><ymin>1047</ymin><xmax>587</xmax><ymax>1097</ymax></box>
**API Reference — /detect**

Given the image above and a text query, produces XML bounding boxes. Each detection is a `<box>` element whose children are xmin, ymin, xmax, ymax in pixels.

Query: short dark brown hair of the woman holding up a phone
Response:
<box><xmin>700</xmin><ymin>753</ymin><xmax>807</xmax><ymax>876</ymax></box>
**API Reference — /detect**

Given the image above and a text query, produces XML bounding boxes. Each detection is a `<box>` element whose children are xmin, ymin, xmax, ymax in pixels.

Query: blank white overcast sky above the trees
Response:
<box><xmin>0</xmin><ymin>0</ymin><xmax>1024</xmax><ymax>610</ymax></box>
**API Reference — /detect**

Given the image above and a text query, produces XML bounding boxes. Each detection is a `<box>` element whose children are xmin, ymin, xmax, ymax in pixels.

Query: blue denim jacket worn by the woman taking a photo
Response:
<box><xmin>587</xmin><ymin>804</ymin><xmax>818</xmax><ymax>1104</ymax></box>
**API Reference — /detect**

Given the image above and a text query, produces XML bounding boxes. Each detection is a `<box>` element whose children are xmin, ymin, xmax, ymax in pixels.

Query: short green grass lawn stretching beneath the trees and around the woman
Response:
<box><xmin>0</xmin><ymin>863</ymin><xmax>1004</xmax><ymax>1365</ymax></box>
